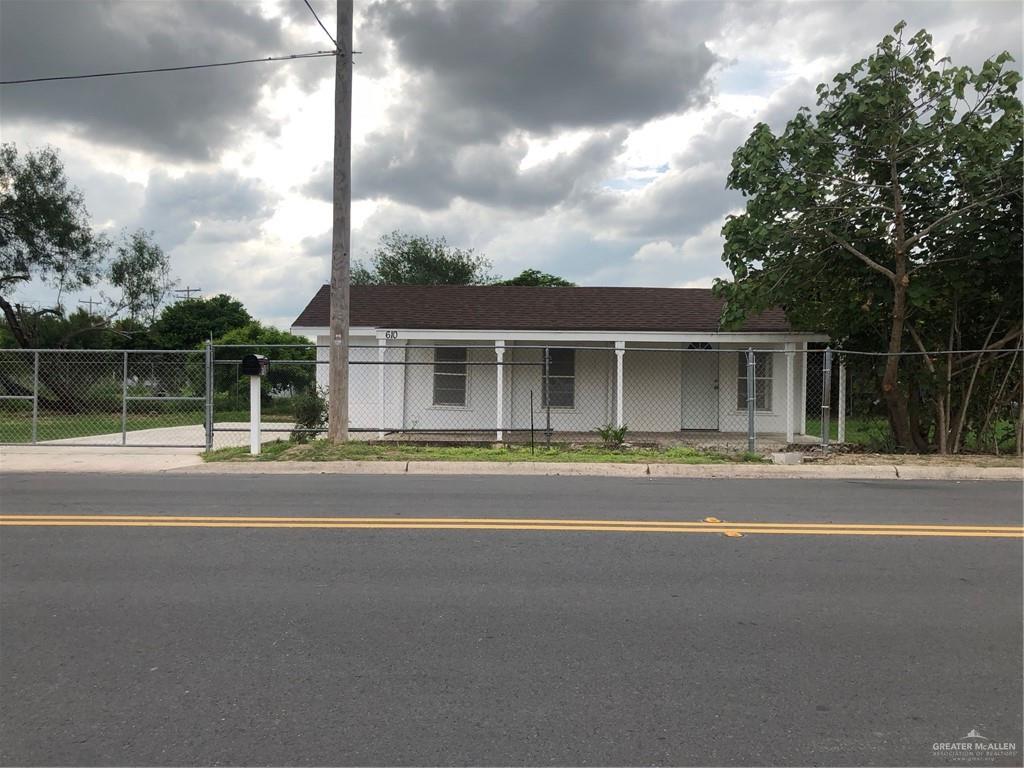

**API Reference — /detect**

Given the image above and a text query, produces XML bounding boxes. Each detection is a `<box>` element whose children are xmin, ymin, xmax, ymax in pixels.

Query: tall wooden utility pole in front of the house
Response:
<box><xmin>328</xmin><ymin>0</ymin><xmax>352</xmax><ymax>443</ymax></box>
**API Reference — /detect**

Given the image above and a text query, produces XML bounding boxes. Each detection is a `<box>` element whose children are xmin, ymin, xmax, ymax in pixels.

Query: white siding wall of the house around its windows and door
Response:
<box><xmin>316</xmin><ymin>336</ymin><xmax>806</xmax><ymax>437</ymax></box>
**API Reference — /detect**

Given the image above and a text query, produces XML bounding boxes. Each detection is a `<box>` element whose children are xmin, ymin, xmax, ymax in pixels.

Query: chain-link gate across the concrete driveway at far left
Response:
<box><xmin>0</xmin><ymin>349</ymin><xmax>207</xmax><ymax>447</ymax></box>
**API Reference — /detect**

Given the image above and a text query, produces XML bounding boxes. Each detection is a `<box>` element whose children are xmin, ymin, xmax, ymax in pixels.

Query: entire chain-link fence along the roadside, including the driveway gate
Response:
<box><xmin>6</xmin><ymin>342</ymin><xmax>1024</xmax><ymax>454</ymax></box>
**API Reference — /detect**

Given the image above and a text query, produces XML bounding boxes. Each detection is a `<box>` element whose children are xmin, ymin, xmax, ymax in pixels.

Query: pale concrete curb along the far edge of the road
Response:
<box><xmin>178</xmin><ymin>461</ymin><xmax>1024</xmax><ymax>482</ymax></box>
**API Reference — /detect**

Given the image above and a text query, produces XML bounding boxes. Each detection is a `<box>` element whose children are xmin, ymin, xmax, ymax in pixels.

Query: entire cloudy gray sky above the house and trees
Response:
<box><xmin>0</xmin><ymin>0</ymin><xmax>1022</xmax><ymax>327</ymax></box>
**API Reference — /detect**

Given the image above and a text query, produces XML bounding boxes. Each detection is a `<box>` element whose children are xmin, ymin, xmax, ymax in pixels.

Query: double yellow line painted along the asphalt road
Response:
<box><xmin>0</xmin><ymin>515</ymin><xmax>1024</xmax><ymax>539</ymax></box>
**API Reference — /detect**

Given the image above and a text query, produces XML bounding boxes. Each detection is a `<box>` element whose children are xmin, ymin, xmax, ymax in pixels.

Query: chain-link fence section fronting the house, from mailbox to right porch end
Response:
<box><xmin>213</xmin><ymin>342</ymin><xmax>813</xmax><ymax>451</ymax></box>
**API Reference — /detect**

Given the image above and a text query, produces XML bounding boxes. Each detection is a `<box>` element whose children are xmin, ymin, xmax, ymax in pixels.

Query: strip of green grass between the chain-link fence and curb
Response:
<box><xmin>204</xmin><ymin>440</ymin><xmax>764</xmax><ymax>464</ymax></box>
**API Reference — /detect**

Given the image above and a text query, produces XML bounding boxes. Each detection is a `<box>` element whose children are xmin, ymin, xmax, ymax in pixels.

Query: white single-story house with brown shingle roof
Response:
<box><xmin>292</xmin><ymin>286</ymin><xmax>826</xmax><ymax>442</ymax></box>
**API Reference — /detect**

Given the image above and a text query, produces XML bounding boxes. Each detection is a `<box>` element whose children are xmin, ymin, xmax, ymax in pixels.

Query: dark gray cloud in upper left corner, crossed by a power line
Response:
<box><xmin>0</xmin><ymin>0</ymin><xmax>331</xmax><ymax>161</ymax></box>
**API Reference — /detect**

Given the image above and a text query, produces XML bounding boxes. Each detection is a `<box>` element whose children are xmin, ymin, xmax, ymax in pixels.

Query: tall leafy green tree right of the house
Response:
<box><xmin>716</xmin><ymin>23</ymin><xmax>1021</xmax><ymax>450</ymax></box>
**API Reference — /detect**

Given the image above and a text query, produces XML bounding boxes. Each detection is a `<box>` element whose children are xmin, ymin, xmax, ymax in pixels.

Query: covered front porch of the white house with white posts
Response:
<box><xmin>317</xmin><ymin>329</ymin><xmax>831</xmax><ymax>450</ymax></box>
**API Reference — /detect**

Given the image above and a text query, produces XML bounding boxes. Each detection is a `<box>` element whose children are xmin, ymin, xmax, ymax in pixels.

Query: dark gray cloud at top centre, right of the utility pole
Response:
<box><xmin>367</xmin><ymin>0</ymin><xmax>722</xmax><ymax>138</ymax></box>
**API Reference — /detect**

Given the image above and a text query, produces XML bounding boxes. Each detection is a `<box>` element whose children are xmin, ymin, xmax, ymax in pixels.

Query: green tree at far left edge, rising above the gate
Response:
<box><xmin>0</xmin><ymin>143</ymin><xmax>110</xmax><ymax>347</ymax></box>
